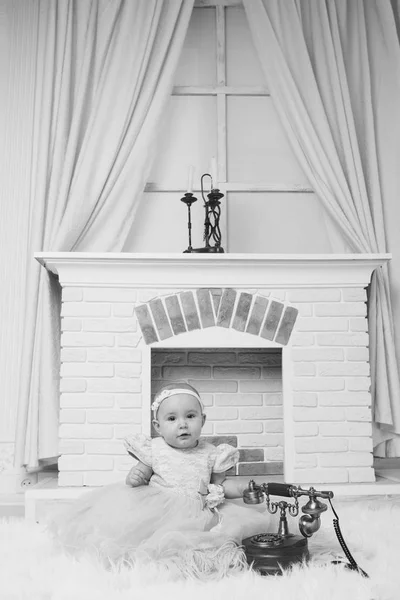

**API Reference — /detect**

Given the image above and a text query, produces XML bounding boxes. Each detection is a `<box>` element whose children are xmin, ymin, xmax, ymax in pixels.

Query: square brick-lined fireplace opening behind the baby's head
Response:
<box><xmin>148</xmin><ymin>348</ymin><xmax>284</xmax><ymax>476</ymax></box>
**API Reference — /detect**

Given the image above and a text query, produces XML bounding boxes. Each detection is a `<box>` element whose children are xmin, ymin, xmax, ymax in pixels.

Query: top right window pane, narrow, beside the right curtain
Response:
<box><xmin>225</xmin><ymin>7</ymin><xmax>266</xmax><ymax>86</ymax></box>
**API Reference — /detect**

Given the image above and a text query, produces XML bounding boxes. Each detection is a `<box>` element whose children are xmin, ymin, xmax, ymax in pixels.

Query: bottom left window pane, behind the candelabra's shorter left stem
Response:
<box><xmin>124</xmin><ymin>192</ymin><xmax>208</xmax><ymax>253</ymax></box>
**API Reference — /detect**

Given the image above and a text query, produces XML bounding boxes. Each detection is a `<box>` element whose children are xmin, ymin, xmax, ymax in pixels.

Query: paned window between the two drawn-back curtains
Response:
<box><xmin>126</xmin><ymin>0</ymin><xmax>332</xmax><ymax>253</ymax></box>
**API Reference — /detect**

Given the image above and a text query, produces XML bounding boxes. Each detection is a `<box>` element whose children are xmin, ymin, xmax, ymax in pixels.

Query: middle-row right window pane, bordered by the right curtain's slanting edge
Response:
<box><xmin>227</xmin><ymin>96</ymin><xmax>308</xmax><ymax>185</ymax></box>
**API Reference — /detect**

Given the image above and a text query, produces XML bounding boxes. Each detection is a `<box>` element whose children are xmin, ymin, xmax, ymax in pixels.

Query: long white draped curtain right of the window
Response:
<box><xmin>244</xmin><ymin>0</ymin><xmax>400</xmax><ymax>456</ymax></box>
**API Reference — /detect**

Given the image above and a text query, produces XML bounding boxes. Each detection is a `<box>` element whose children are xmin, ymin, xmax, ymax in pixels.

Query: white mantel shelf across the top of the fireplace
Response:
<box><xmin>35</xmin><ymin>252</ymin><xmax>391</xmax><ymax>289</ymax></box>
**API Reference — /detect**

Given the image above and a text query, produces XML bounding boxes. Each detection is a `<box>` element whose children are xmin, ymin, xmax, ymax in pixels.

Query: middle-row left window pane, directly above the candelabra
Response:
<box><xmin>149</xmin><ymin>96</ymin><xmax>217</xmax><ymax>190</ymax></box>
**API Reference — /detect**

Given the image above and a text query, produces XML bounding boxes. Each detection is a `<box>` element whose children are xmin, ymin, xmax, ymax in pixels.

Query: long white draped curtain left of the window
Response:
<box><xmin>15</xmin><ymin>0</ymin><xmax>194</xmax><ymax>468</ymax></box>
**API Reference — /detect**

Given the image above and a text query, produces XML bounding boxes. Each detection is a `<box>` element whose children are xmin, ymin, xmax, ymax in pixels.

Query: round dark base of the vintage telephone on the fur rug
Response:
<box><xmin>242</xmin><ymin>533</ymin><xmax>310</xmax><ymax>575</ymax></box>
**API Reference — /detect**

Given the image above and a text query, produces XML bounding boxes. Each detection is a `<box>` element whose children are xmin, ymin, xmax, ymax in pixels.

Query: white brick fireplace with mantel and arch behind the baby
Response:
<box><xmin>36</xmin><ymin>253</ymin><xmax>390</xmax><ymax>487</ymax></box>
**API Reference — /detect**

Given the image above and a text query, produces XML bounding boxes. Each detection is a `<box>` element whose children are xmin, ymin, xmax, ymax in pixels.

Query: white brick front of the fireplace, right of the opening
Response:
<box><xmin>288</xmin><ymin>288</ymin><xmax>374</xmax><ymax>483</ymax></box>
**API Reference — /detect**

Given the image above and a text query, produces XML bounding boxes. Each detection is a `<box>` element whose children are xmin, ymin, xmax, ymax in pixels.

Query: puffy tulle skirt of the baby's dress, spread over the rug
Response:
<box><xmin>48</xmin><ymin>483</ymin><xmax>270</xmax><ymax>577</ymax></box>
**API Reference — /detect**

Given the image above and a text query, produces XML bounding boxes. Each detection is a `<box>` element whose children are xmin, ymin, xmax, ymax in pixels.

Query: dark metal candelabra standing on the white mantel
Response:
<box><xmin>181</xmin><ymin>173</ymin><xmax>225</xmax><ymax>254</ymax></box>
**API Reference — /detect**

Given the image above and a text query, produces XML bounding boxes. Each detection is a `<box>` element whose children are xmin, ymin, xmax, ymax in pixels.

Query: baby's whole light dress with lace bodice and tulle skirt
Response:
<box><xmin>50</xmin><ymin>435</ymin><xmax>269</xmax><ymax>576</ymax></box>
